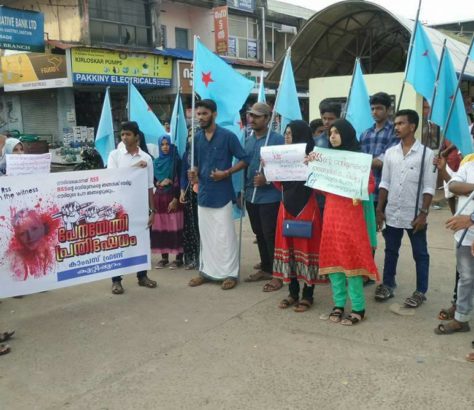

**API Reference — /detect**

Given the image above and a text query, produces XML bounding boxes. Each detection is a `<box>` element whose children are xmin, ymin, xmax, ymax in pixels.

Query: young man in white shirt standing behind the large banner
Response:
<box><xmin>107</xmin><ymin>121</ymin><xmax>157</xmax><ymax>295</ymax></box>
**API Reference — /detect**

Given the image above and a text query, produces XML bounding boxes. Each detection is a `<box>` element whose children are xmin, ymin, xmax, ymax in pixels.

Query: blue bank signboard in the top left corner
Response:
<box><xmin>0</xmin><ymin>6</ymin><xmax>44</xmax><ymax>52</ymax></box>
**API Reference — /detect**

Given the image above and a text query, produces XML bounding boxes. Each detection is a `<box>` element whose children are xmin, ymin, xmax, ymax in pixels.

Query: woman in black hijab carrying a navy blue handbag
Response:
<box><xmin>273</xmin><ymin>120</ymin><xmax>321</xmax><ymax>312</ymax></box>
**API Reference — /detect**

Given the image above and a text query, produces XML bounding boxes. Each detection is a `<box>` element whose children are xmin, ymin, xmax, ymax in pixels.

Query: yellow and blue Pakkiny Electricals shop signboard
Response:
<box><xmin>71</xmin><ymin>48</ymin><xmax>173</xmax><ymax>87</ymax></box>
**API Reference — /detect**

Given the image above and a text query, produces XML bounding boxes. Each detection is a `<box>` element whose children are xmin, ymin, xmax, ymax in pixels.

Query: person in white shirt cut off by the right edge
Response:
<box><xmin>435</xmin><ymin>162</ymin><xmax>474</xmax><ymax>335</ymax></box>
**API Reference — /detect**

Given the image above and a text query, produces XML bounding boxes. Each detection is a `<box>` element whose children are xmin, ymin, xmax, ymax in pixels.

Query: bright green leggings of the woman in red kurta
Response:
<box><xmin>329</xmin><ymin>272</ymin><xmax>365</xmax><ymax>312</ymax></box>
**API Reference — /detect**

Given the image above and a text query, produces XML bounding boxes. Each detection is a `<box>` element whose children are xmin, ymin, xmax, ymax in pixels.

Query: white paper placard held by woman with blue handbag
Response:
<box><xmin>260</xmin><ymin>144</ymin><xmax>308</xmax><ymax>181</ymax></box>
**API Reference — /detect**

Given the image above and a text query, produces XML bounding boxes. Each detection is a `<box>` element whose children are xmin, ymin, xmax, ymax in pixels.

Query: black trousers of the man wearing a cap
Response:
<box><xmin>246</xmin><ymin>202</ymin><xmax>280</xmax><ymax>273</ymax></box>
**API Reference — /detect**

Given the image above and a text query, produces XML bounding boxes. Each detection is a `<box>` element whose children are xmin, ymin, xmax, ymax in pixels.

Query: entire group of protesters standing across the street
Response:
<box><xmin>0</xmin><ymin>92</ymin><xmax>474</xmax><ymax>361</ymax></box>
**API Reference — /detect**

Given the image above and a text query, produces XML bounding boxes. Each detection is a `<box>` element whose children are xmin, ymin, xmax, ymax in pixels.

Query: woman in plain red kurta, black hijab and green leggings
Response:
<box><xmin>310</xmin><ymin>119</ymin><xmax>378</xmax><ymax>325</ymax></box>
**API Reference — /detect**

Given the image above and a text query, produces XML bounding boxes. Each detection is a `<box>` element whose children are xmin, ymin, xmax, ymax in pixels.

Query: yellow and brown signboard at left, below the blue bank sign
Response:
<box><xmin>1</xmin><ymin>53</ymin><xmax>72</xmax><ymax>92</ymax></box>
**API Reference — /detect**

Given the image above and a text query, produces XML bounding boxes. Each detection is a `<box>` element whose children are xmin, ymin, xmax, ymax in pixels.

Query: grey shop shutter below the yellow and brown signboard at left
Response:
<box><xmin>21</xmin><ymin>90</ymin><xmax>59</xmax><ymax>142</ymax></box>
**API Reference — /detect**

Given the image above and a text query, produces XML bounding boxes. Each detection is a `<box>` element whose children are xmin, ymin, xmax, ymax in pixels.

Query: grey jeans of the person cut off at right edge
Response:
<box><xmin>454</xmin><ymin>246</ymin><xmax>474</xmax><ymax>322</ymax></box>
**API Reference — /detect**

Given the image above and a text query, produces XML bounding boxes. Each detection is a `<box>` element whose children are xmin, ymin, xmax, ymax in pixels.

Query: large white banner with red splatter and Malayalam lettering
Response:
<box><xmin>0</xmin><ymin>168</ymin><xmax>150</xmax><ymax>298</ymax></box>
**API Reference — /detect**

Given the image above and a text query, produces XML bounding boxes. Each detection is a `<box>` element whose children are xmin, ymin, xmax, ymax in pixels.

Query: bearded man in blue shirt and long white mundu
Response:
<box><xmin>188</xmin><ymin>99</ymin><xmax>250</xmax><ymax>290</ymax></box>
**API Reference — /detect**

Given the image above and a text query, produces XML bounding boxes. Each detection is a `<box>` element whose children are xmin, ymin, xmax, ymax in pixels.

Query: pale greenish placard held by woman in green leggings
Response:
<box><xmin>306</xmin><ymin>148</ymin><xmax>372</xmax><ymax>200</ymax></box>
